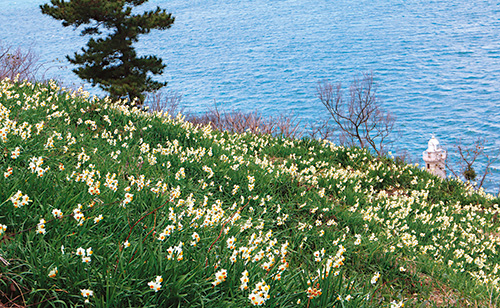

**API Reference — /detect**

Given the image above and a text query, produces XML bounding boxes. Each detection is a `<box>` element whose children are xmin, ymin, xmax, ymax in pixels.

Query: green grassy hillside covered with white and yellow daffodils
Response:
<box><xmin>0</xmin><ymin>80</ymin><xmax>500</xmax><ymax>307</ymax></box>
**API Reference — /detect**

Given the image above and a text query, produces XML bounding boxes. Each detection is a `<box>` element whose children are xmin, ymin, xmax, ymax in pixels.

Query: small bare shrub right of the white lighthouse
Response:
<box><xmin>446</xmin><ymin>138</ymin><xmax>498</xmax><ymax>189</ymax></box>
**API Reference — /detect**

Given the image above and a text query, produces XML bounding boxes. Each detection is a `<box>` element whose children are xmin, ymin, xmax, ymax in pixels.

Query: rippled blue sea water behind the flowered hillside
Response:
<box><xmin>0</xmin><ymin>0</ymin><xmax>500</xmax><ymax>193</ymax></box>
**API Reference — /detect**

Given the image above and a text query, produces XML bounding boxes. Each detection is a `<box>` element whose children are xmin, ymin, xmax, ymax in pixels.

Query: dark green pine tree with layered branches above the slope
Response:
<box><xmin>40</xmin><ymin>0</ymin><xmax>174</xmax><ymax>103</ymax></box>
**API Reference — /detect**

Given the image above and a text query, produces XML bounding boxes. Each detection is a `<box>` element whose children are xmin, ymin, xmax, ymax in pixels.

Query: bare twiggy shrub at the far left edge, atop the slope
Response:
<box><xmin>0</xmin><ymin>44</ymin><xmax>41</xmax><ymax>80</ymax></box>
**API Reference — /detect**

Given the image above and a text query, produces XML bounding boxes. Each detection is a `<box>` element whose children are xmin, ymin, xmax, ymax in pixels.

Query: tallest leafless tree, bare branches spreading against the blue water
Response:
<box><xmin>316</xmin><ymin>73</ymin><xmax>396</xmax><ymax>155</ymax></box>
